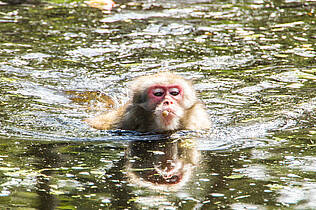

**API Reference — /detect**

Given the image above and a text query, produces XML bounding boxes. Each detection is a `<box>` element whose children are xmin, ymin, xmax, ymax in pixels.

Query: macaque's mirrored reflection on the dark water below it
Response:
<box><xmin>126</xmin><ymin>140</ymin><xmax>199</xmax><ymax>190</ymax></box>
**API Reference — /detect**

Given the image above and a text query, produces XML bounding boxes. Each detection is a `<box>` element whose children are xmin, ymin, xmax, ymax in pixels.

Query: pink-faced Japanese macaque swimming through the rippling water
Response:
<box><xmin>86</xmin><ymin>72</ymin><xmax>210</xmax><ymax>132</ymax></box>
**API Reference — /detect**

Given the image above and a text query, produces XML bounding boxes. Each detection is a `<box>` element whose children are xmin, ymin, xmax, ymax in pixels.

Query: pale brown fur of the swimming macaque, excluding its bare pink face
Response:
<box><xmin>86</xmin><ymin>72</ymin><xmax>210</xmax><ymax>132</ymax></box>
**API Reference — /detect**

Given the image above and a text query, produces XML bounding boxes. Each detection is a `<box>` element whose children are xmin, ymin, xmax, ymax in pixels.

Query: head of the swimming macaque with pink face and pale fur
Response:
<box><xmin>131</xmin><ymin>72</ymin><xmax>197</xmax><ymax>131</ymax></box>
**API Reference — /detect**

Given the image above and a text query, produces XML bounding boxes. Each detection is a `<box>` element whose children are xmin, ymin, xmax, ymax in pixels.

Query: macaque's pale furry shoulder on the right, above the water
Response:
<box><xmin>183</xmin><ymin>102</ymin><xmax>211</xmax><ymax>130</ymax></box>
